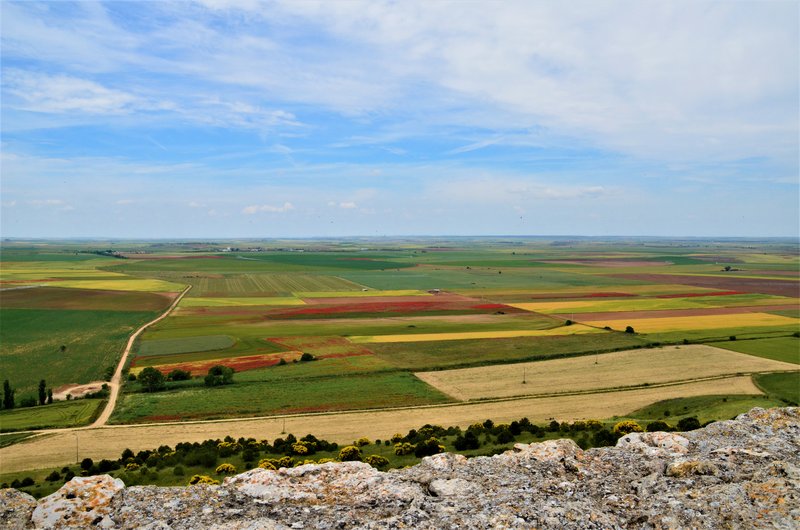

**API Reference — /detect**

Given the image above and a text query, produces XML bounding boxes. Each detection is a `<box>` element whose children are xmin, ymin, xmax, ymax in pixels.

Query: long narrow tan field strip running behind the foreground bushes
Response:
<box><xmin>0</xmin><ymin>376</ymin><xmax>761</xmax><ymax>473</ymax></box>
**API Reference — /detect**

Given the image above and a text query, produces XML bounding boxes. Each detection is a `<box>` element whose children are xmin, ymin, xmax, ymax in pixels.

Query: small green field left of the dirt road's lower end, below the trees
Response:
<box><xmin>0</xmin><ymin>399</ymin><xmax>105</xmax><ymax>432</ymax></box>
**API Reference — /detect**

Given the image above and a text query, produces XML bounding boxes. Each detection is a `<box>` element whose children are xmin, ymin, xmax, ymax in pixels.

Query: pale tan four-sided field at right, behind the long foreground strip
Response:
<box><xmin>415</xmin><ymin>345</ymin><xmax>797</xmax><ymax>400</ymax></box>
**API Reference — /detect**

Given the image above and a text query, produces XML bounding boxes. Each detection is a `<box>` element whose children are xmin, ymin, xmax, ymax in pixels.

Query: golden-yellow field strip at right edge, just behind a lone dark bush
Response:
<box><xmin>584</xmin><ymin>313</ymin><xmax>800</xmax><ymax>333</ymax></box>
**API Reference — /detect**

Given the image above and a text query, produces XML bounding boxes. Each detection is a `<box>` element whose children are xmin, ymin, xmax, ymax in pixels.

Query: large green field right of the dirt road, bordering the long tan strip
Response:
<box><xmin>112</xmin><ymin>372</ymin><xmax>449</xmax><ymax>423</ymax></box>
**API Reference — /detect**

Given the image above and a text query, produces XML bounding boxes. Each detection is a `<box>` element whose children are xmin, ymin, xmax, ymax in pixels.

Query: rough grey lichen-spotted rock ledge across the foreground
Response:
<box><xmin>0</xmin><ymin>408</ymin><xmax>800</xmax><ymax>530</ymax></box>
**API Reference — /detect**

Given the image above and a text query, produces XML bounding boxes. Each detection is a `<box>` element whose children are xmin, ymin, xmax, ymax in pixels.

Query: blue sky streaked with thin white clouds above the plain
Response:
<box><xmin>0</xmin><ymin>0</ymin><xmax>800</xmax><ymax>238</ymax></box>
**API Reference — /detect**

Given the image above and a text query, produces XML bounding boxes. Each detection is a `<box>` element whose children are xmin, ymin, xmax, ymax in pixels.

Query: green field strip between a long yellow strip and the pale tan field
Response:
<box><xmin>369</xmin><ymin>333</ymin><xmax>644</xmax><ymax>371</ymax></box>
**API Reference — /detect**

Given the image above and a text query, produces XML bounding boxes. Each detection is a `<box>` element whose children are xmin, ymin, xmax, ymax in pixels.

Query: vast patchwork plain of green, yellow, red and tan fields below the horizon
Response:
<box><xmin>0</xmin><ymin>238</ymin><xmax>800</xmax><ymax>470</ymax></box>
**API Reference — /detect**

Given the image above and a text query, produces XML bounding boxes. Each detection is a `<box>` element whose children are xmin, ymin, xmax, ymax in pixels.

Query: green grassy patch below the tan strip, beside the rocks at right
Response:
<box><xmin>617</xmin><ymin>394</ymin><xmax>784</xmax><ymax>425</ymax></box>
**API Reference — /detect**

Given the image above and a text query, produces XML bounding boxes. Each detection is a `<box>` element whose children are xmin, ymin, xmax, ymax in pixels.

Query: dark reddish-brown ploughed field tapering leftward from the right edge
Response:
<box><xmin>608</xmin><ymin>274</ymin><xmax>800</xmax><ymax>297</ymax></box>
